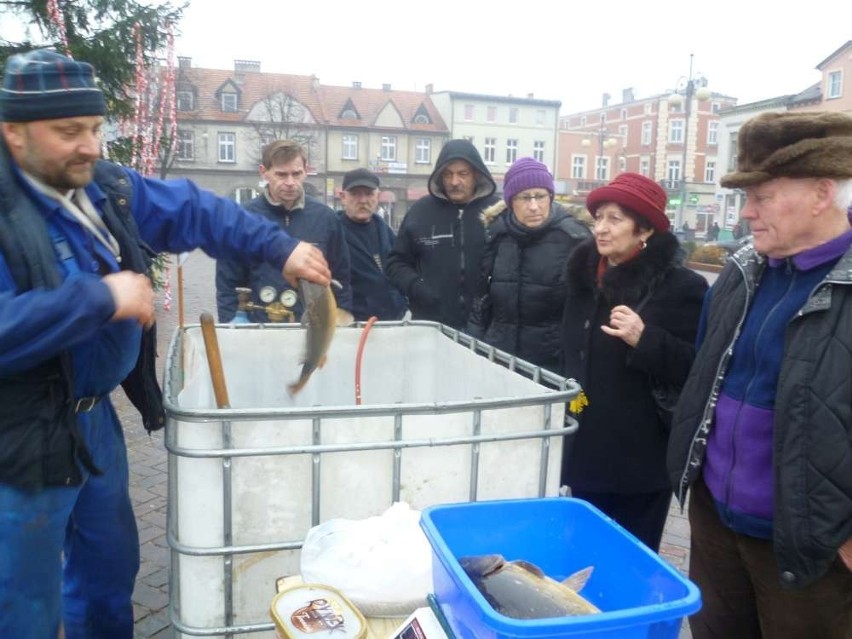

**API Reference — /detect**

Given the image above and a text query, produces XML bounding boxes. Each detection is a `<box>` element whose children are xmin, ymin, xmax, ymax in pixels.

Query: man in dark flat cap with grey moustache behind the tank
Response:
<box><xmin>339</xmin><ymin>169</ymin><xmax>405</xmax><ymax>321</ymax></box>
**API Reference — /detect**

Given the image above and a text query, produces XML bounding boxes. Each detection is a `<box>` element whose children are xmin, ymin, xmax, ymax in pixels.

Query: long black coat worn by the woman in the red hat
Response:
<box><xmin>562</xmin><ymin>233</ymin><xmax>707</xmax><ymax>494</ymax></box>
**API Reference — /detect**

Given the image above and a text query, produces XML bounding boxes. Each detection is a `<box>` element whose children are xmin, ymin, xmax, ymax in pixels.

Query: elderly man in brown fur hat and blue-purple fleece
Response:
<box><xmin>668</xmin><ymin>112</ymin><xmax>852</xmax><ymax>639</ymax></box>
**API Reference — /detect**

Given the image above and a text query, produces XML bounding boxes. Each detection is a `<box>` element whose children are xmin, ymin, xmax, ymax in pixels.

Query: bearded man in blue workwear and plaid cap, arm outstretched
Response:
<box><xmin>0</xmin><ymin>50</ymin><xmax>330</xmax><ymax>639</ymax></box>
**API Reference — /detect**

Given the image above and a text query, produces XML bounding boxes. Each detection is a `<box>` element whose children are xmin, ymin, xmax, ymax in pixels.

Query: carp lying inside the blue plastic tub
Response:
<box><xmin>459</xmin><ymin>555</ymin><xmax>600</xmax><ymax>619</ymax></box>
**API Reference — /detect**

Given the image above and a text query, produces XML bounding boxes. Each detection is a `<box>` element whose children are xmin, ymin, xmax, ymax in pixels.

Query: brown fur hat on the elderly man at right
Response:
<box><xmin>719</xmin><ymin>111</ymin><xmax>852</xmax><ymax>188</ymax></box>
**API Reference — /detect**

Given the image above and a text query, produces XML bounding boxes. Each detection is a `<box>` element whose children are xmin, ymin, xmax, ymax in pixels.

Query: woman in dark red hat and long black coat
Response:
<box><xmin>562</xmin><ymin>173</ymin><xmax>707</xmax><ymax>551</ymax></box>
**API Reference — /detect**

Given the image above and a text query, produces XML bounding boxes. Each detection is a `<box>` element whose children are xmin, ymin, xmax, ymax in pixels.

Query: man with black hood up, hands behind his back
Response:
<box><xmin>387</xmin><ymin>140</ymin><xmax>499</xmax><ymax>329</ymax></box>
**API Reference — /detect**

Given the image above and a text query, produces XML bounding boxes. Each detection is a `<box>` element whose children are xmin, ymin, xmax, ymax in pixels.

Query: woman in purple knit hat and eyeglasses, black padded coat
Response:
<box><xmin>468</xmin><ymin>158</ymin><xmax>590</xmax><ymax>372</ymax></box>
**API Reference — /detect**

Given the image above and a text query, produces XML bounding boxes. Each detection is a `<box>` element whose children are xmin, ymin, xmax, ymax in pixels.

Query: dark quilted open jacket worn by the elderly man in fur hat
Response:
<box><xmin>669</xmin><ymin>248</ymin><xmax>852</xmax><ymax>586</ymax></box>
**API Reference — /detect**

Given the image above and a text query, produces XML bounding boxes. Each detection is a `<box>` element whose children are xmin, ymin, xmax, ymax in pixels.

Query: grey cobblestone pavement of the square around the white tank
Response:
<box><xmin>126</xmin><ymin>252</ymin><xmax>690</xmax><ymax>639</ymax></box>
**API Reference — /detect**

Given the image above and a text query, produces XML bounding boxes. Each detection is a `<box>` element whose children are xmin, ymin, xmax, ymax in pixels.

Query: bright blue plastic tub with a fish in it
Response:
<box><xmin>421</xmin><ymin>497</ymin><xmax>701</xmax><ymax>639</ymax></box>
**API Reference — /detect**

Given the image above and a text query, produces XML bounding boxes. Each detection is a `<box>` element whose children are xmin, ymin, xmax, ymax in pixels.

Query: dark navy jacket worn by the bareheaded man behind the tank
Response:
<box><xmin>216</xmin><ymin>190</ymin><xmax>352</xmax><ymax>322</ymax></box>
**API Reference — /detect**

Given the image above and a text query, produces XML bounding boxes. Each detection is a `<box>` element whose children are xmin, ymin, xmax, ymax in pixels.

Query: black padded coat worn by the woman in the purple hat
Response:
<box><xmin>468</xmin><ymin>202</ymin><xmax>590</xmax><ymax>372</ymax></box>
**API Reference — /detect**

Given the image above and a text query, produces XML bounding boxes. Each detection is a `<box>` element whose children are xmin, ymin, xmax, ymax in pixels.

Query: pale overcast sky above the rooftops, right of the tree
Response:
<box><xmin>170</xmin><ymin>0</ymin><xmax>852</xmax><ymax>113</ymax></box>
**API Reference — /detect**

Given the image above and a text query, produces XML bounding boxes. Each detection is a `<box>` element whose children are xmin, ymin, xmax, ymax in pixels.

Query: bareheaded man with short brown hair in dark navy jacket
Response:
<box><xmin>216</xmin><ymin>140</ymin><xmax>352</xmax><ymax>322</ymax></box>
